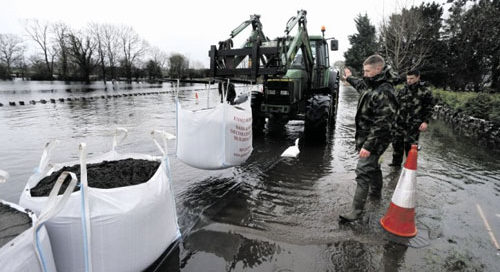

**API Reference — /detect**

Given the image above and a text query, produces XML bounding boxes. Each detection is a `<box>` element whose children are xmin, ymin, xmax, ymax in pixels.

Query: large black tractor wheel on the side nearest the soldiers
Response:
<box><xmin>304</xmin><ymin>94</ymin><xmax>333</xmax><ymax>139</ymax></box>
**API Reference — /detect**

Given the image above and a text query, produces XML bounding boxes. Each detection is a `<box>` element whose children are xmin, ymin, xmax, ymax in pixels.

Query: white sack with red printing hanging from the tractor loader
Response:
<box><xmin>177</xmin><ymin>90</ymin><xmax>253</xmax><ymax>170</ymax></box>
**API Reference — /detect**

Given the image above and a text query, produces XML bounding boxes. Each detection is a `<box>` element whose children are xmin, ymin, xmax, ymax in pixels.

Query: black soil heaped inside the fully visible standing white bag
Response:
<box><xmin>31</xmin><ymin>159</ymin><xmax>160</xmax><ymax>197</ymax></box>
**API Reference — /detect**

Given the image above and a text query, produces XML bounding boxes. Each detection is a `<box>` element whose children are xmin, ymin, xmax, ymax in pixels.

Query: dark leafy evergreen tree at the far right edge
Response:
<box><xmin>443</xmin><ymin>0</ymin><xmax>500</xmax><ymax>92</ymax></box>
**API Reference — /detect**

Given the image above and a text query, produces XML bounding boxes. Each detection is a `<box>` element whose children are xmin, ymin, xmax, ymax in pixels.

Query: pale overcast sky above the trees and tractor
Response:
<box><xmin>0</xmin><ymin>0</ymin><xmax>443</xmax><ymax>66</ymax></box>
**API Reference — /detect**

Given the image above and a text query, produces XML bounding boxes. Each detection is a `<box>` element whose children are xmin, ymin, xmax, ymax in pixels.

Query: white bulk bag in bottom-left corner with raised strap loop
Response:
<box><xmin>0</xmin><ymin>172</ymin><xmax>76</xmax><ymax>272</ymax></box>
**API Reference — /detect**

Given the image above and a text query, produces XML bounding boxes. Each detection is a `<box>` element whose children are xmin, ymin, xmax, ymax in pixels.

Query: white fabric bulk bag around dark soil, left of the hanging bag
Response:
<box><xmin>20</xmin><ymin>129</ymin><xmax>180</xmax><ymax>272</ymax></box>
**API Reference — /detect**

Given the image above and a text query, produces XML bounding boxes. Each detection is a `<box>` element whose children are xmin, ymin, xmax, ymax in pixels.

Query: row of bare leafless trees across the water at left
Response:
<box><xmin>0</xmin><ymin>19</ymin><xmax>207</xmax><ymax>82</ymax></box>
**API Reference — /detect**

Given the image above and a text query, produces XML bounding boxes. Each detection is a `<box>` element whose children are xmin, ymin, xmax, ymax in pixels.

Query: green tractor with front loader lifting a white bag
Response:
<box><xmin>209</xmin><ymin>10</ymin><xmax>339</xmax><ymax>138</ymax></box>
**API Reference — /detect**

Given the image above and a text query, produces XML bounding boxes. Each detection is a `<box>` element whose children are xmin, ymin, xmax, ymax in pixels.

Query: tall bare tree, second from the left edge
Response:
<box><xmin>25</xmin><ymin>19</ymin><xmax>55</xmax><ymax>79</ymax></box>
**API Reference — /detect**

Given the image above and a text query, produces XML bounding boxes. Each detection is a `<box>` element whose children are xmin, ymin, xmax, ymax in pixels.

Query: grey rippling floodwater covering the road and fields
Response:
<box><xmin>0</xmin><ymin>79</ymin><xmax>500</xmax><ymax>271</ymax></box>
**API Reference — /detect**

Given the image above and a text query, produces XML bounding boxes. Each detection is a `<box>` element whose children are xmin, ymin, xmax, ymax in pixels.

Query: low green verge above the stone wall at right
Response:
<box><xmin>432</xmin><ymin>89</ymin><xmax>500</xmax><ymax>124</ymax></box>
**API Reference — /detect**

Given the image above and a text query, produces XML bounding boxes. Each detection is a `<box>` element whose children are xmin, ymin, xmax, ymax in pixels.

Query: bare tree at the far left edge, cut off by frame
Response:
<box><xmin>0</xmin><ymin>34</ymin><xmax>25</xmax><ymax>77</ymax></box>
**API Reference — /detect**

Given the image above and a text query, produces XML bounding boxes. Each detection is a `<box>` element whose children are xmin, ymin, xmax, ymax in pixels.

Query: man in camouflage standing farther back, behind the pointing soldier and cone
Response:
<box><xmin>389</xmin><ymin>70</ymin><xmax>434</xmax><ymax>167</ymax></box>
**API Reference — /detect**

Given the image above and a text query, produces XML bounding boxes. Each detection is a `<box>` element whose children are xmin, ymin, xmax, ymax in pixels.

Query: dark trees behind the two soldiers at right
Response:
<box><xmin>342</xmin><ymin>0</ymin><xmax>500</xmax><ymax>92</ymax></box>
